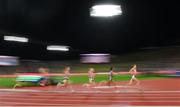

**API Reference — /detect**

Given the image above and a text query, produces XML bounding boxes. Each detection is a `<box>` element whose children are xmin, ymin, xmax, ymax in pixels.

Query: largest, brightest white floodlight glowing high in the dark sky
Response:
<box><xmin>90</xmin><ymin>4</ymin><xmax>122</xmax><ymax>17</ymax></box>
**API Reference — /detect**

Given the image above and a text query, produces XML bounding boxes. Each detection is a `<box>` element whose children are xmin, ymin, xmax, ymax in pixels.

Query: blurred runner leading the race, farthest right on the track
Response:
<box><xmin>128</xmin><ymin>65</ymin><xmax>140</xmax><ymax>85</ymax></box>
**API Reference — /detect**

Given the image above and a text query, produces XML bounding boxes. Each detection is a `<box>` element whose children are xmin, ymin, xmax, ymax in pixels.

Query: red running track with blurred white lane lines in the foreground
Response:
<box><xmin>0</xmin><ymin>79</ymin><xmax>180</xmax><ymax>106</ymax></box>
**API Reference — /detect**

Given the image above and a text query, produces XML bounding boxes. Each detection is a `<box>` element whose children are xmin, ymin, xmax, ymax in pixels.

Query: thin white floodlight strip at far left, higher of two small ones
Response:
<box><xmin>4</xmin><ymin>36</ymin><xmax>28</xmax><ymax>42</ymax></box>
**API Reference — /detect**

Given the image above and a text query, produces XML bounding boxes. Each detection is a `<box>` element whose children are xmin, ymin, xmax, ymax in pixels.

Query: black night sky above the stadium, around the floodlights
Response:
<box><xmin>0</xmin><ymin>0</ymin><xmax>180</xmax><ymax>59</ymax></box>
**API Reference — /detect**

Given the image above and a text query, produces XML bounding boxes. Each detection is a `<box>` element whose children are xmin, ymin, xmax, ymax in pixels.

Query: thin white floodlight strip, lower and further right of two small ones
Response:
<box><xmin>47</xmin><ymin>45</ymin><xmax>69</xmax><ymax>51</ymax></box>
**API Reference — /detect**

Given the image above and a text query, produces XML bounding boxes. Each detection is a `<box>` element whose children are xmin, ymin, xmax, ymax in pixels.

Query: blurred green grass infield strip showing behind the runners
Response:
<box><xmin>0</xmin><ymin>74</ymin><xmax>165</xmax><ymax>88</ymax></box>
